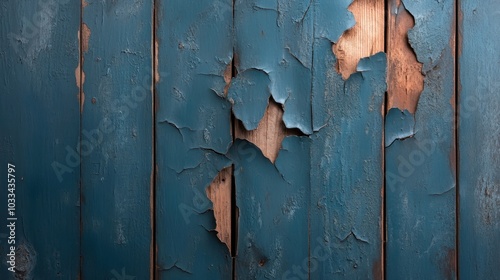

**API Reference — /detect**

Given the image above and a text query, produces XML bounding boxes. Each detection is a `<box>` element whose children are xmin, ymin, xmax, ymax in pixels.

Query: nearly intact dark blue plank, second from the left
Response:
<box><xmin>81</xmin><ymin>0</ymin><xmax>153</xmax><ymax>279</ymax></box>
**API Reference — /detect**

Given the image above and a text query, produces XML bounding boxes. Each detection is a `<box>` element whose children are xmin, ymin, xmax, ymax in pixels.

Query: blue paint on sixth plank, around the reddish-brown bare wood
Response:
<box><xmin>386</xmin><ymin>0</ymin><xmax>456</xmax><ymax>279</ymax></box>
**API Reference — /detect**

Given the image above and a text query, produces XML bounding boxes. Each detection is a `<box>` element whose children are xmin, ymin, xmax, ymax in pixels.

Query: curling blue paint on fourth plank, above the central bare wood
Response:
<box><xmin>234</xmin><ymin>0</ymin><xmax>314</xmax><ymax>134</ymax></box>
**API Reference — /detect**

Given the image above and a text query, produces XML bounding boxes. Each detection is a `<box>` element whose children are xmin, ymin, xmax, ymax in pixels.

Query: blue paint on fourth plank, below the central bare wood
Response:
<box><xmin>229</xmin><ymin>136</ymin><xmax>310</xmax><ymax>279</ymax></box>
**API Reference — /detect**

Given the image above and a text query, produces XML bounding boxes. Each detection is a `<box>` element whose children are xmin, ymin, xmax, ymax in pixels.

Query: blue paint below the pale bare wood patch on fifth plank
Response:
<box><xmin>310</xmin><ymin>52</ymin><xmax>386</xmax><ymax>279</ymax></box>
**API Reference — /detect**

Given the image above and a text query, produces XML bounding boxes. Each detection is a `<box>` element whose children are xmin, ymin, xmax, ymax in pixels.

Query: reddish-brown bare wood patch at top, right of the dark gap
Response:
<box><xmin>386</xmin><ymin>0</ymin><xmax>424</xmax><ymax>114</ymax></box>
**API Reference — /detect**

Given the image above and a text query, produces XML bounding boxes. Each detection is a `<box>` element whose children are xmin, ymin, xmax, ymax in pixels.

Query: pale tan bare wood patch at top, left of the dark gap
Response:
<box><xmin>333</xmin><ymin>0</ymin><xmax>384</xmax><ymax>80</ymax></box>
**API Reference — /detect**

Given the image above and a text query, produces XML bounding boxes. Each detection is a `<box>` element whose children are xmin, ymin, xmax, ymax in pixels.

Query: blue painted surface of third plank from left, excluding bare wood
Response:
<box><xmin>155</xmin><ymin>0</ymin><xmax>233</xmax><ymax>279</ymax></box>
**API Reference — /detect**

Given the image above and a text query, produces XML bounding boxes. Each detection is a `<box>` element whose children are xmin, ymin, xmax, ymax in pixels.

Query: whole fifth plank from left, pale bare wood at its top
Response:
<box><xmin>309</xmin><ymin>1</ymin><xmax>386</xmax><ymax>279</ymax></box>
